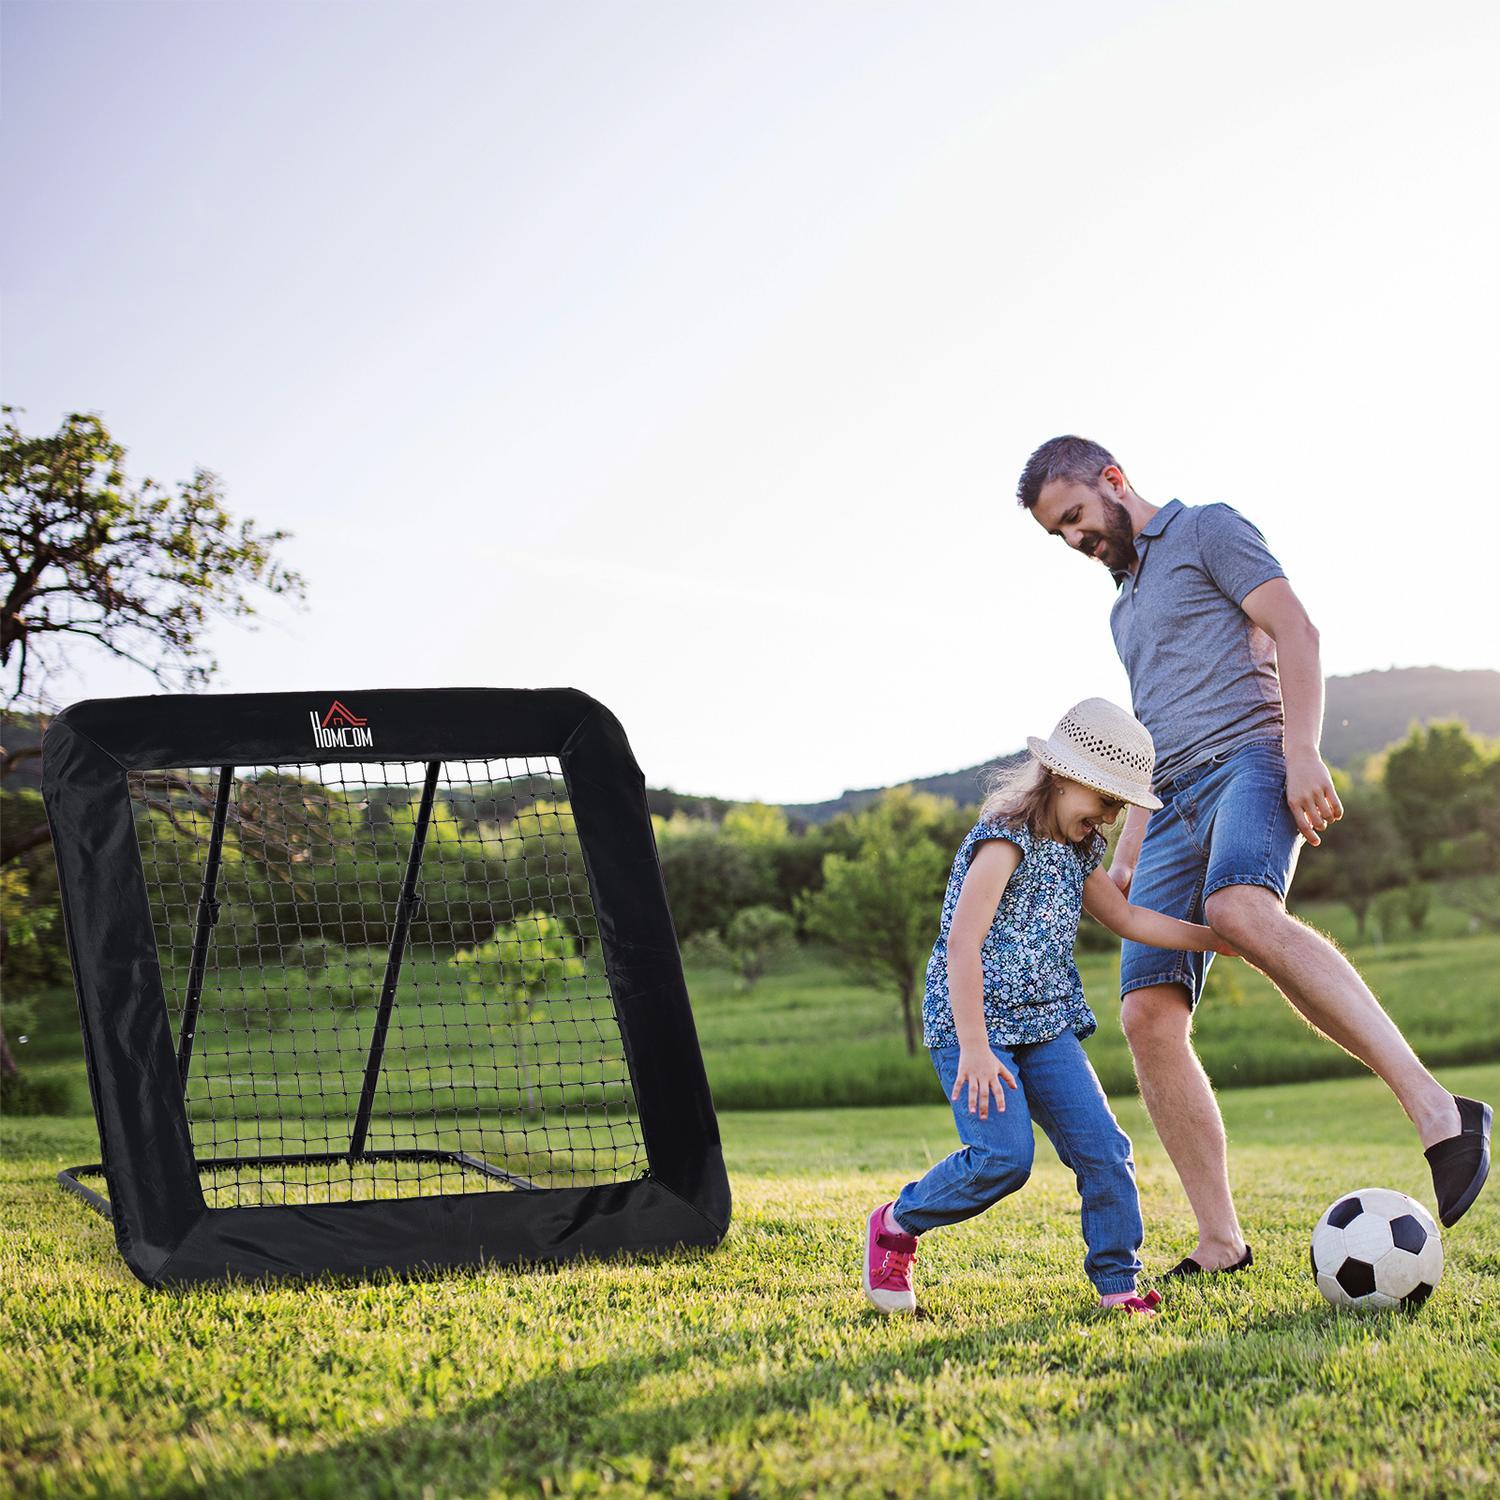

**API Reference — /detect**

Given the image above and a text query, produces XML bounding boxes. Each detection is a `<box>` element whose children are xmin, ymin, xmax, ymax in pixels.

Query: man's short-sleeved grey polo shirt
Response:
<box><xmin>1110</xmin><ymin>500</ymin><xmax>1287</xmax><ymax>794</ymax></box>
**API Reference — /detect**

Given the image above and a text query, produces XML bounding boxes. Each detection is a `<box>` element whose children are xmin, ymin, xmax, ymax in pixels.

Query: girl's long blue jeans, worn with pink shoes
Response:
<box><xmin>893</xmin><ymin>1032</ymin><xmax>1142</xmax><ymax>1295</ymax></box>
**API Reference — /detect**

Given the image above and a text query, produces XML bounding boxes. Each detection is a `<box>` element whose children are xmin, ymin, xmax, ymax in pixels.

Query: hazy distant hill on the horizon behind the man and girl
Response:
<box><xmin>785</xmin><ymin>666</ymin><xmax>1500</xmax><ymax>824</ymax></box>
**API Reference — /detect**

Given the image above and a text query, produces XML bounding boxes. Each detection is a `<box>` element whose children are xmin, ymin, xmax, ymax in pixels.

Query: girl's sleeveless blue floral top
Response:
<box><xmin>923</xmin><ymin>822</ymin><xmax>1107</xmax><ymax>1047</ymax></box>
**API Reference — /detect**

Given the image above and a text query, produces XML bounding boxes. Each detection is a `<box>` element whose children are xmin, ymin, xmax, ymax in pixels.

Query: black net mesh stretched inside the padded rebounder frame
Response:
<box><xmin>131</xmin><ymin>756</ymin><xmax>647</xmax><ymax>1208</ymax></box>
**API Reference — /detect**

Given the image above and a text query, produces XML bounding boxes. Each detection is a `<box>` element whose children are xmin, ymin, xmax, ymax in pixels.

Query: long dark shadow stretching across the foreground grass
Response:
<box><xmin>187</xmin><ymin>1310</ymin><xmax>1404</xmax><ymax>1497</ymax></box>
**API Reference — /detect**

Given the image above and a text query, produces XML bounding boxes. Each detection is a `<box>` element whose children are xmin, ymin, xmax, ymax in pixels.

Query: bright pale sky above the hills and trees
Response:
<box><xmin>0</xmin><ymin>0</ymin><xmax>1500</xmax><ymax>801</ymax></box>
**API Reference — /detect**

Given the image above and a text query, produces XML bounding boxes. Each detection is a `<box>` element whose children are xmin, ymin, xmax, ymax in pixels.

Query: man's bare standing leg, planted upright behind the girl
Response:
<box><xmin>1121</xmin><ymin>984</ymin><xmax>1245</xmax><ymax>1271</ymax></box>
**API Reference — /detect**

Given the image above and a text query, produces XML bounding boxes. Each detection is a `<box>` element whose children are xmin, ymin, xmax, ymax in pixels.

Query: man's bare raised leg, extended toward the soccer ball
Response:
<box><xmin>1206</xmin><ymin>885</ymin><xmax>1460</xmax><ymax>1148</ymax></box>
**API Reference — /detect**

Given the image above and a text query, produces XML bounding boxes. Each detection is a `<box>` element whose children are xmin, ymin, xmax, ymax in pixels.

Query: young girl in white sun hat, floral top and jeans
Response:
<box><xmin>864</xmin><ymin>698</ymin><xmax>1235</xmax><ymax>1317</ymax></box>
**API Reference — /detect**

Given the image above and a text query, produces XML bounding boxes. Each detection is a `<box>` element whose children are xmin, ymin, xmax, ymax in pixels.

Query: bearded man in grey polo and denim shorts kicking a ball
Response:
<box><xmin>1017</xmin><ymin>437</ymin><xmax>1493</xmax><ymax>1275</ymax></box>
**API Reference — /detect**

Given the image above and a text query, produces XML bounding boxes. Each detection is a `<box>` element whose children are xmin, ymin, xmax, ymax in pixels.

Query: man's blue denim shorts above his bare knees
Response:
<box><xmin>1121</xmin><ymin>737</ymin><xmax>1304</xmax><ymax>1007</ymax></box>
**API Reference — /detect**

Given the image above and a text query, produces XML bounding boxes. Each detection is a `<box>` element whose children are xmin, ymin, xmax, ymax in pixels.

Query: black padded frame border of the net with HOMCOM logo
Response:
<box><xmin>42</xmin><ymin>689</ymin><xmax>731</xmax><ymax>1286</ymax></box>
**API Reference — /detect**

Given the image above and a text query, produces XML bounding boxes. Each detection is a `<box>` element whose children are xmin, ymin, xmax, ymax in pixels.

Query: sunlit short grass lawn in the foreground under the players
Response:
<box><xmin>0</xmin><ymin>1065</ymin><xmax>1500</xmax><ymax>1497</ymax></box>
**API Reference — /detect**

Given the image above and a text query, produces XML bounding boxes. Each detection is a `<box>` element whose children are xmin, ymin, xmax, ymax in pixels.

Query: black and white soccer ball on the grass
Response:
<box><xmin>1313</xmin><ymin>1188</ymin><xmax>1443</xmax><ymax>1308</ymax></box>
